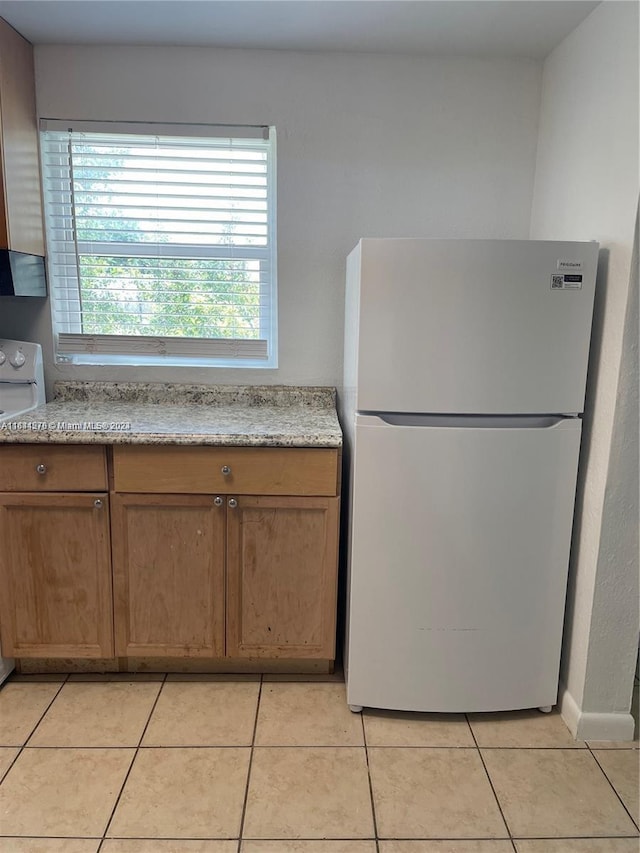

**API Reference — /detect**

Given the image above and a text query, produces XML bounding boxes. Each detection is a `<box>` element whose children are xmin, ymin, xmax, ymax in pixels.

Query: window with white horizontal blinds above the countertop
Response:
<box><xmin>41</xmin><ymin>120</ymin><xmax>277</xmax><ymax>367</ymax></box>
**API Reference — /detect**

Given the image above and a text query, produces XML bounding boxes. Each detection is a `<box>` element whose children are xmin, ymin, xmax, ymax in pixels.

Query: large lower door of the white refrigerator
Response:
<box><xmin>345</xmin><ymin>415</ymin><xmax>581</xmax><ymax>712</ymax></box>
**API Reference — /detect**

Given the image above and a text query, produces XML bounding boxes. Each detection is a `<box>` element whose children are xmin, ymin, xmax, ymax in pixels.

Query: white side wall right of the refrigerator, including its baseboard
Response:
<box><xmin>531</xmin><ymin>2</ymin><xmax>639</xmax><ymax>738</ymax></box>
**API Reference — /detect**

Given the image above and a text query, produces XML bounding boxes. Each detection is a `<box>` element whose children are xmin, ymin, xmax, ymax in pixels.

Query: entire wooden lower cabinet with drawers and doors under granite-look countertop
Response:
<box><xmin>0</xmin><ymin>446</ymin><xmax>339</xmax><ymax>671</ymax></box>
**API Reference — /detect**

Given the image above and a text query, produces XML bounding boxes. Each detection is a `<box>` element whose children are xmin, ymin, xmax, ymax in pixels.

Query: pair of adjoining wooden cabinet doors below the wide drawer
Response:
<box><xmin>112</xmin><ymin>494</ymin><xmax>339</xmax><ymax>660</ymax></box>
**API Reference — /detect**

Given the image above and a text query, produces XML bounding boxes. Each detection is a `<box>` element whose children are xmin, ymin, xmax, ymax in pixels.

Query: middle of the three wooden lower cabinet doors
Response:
<box><xmin>113</xmin><ymin>494</ymin><xmax>225</xmax><ymax>657</ymax></box>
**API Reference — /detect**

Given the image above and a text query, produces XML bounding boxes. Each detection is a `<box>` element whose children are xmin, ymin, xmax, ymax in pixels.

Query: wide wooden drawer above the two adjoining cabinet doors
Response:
<box><xmin>113</xmin><ymin>446</ymin><xmax>338</xmax><ymax>495</ymax></box>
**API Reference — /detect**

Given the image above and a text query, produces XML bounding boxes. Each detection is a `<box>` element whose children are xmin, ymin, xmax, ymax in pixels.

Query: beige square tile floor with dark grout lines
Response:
<box><xmin>0</xmin><ymin>675</ymin><xmax>640</xmax><ymax>853</ymax></box>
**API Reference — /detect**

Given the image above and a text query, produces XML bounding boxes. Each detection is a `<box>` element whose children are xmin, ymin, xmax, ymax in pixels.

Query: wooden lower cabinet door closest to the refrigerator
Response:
<box><xmin>227</xmin><ymin>497</ymin><xmax>339</xmax><ymax>659</ymax></box>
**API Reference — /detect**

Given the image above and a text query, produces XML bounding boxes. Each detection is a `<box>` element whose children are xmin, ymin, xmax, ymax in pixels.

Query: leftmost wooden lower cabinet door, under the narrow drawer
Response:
<box><xmin>0</xmin><ymin>493</ymin><xmax>113</xmax><ymax>658</ymax></box>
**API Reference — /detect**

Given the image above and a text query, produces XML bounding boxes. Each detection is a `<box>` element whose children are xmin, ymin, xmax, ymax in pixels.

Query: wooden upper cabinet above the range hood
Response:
<box><xmin>0</xmin><ymin>18</ymin><xmax>44</xmax><ymax>255</ymax></box>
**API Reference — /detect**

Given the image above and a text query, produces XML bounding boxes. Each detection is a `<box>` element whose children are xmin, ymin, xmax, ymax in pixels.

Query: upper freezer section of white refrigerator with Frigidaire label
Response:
<box><xmin>345</xmin><ymin>239</ymin><xmax>598</xmax><ymax>414</ymax></box>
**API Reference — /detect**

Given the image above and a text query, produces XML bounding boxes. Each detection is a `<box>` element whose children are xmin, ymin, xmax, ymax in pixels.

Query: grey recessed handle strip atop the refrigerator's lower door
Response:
<box><xmin>356</xmin><ymin>412</ymin><xmax>582</xmax><ymax>430</ymax></box>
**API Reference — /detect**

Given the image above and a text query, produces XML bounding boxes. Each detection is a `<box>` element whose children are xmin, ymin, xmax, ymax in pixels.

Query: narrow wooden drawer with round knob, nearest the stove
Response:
<box><xmin>0</xmin><ymin>444</ymin><xmax>107</xmax><ymax>492</ymax></box>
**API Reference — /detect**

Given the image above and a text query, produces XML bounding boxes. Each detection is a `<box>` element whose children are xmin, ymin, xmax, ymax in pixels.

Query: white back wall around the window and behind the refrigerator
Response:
<box><xmin>0</xmin><ymin>46</ymin><xmax>541</xmax><ymax>392</ymax></box>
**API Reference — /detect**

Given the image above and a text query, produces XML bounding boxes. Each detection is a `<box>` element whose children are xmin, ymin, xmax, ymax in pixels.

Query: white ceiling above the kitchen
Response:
<box><xmin>0</xmin><ymin>0</ymin><xmax>599</xmax><ymax>59</ymax></box>
